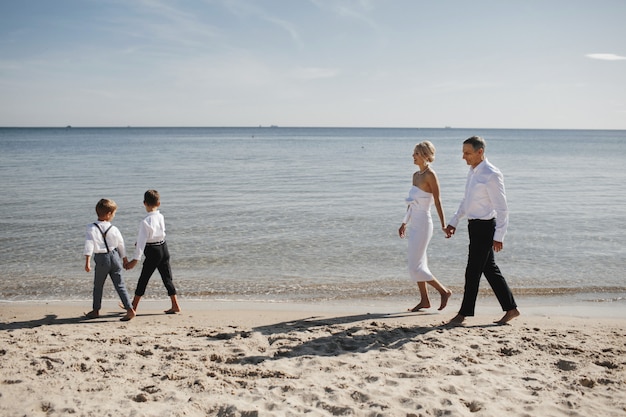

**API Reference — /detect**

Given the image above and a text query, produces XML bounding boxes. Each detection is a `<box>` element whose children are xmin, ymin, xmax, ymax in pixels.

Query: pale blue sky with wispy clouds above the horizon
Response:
<box><xmin>0</xmin><ymin>0</ymin><xmax>626</xmax><ymax>129</ymax></box>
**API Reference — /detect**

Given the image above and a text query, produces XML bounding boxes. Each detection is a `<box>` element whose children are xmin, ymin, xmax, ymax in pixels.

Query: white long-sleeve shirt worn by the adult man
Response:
<box><xmin>449</xmin><ymin>159</ymin><xmax>509</xmax><ymax>242</ymax></box>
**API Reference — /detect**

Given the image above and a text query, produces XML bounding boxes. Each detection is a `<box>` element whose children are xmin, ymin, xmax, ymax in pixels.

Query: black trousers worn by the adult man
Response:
<box><xmin>459</xmin><ymin>219</ymin><xmax>517</xmax><ymax>317</ymax></box>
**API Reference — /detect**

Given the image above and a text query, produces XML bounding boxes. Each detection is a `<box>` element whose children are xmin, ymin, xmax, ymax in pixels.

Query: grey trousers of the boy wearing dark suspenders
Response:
<box><xmin>93</xmin><ymin>250</ymin><xmax>133</xmax><ymax>310</ymax></box>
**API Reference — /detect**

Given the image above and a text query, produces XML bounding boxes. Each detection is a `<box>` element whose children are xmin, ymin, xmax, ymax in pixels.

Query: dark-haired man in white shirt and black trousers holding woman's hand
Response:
<box><xmin>445</xmin><ymin>136</ymin><xmax>520</xmax><ymax>324</ymax></box>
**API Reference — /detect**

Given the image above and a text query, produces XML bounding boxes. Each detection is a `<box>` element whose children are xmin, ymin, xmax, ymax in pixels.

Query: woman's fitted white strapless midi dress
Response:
<box><xmin>403</xmin><ymin>186</ymin><xmax>434</xmax><ymax>282</ymax></box>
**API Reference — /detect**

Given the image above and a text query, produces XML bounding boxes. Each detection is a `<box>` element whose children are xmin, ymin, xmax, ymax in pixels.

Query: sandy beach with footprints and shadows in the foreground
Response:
<box><xmin>0</xmin><ymin>300</ymin><xmax>626</xmax><ymax>417</ymax></box>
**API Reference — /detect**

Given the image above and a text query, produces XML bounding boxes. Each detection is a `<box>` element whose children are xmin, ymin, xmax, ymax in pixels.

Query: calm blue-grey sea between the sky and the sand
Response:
<box><xmin>0</xmin><ymin>127</ymin><xmax>626</xmax><ymax>302</ymax></box>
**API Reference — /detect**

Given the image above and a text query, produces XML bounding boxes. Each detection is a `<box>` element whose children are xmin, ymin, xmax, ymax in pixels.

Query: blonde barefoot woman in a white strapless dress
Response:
<box><xmin>398</xmin><ymin>141</ymin><xmax>452</xmax><ymax>311</ymax></box>
